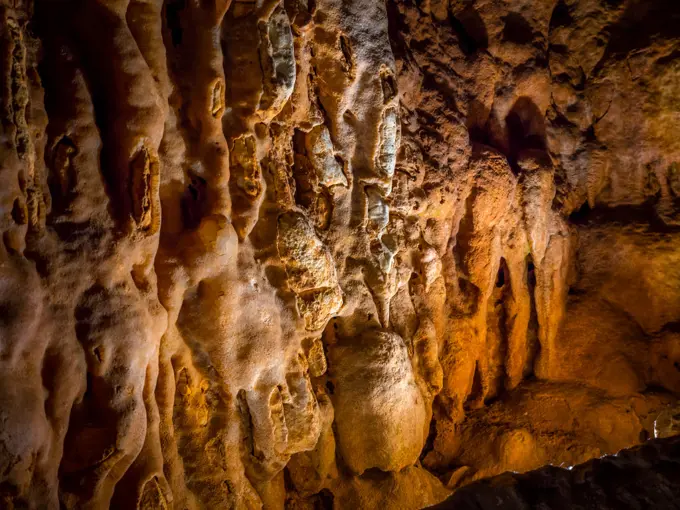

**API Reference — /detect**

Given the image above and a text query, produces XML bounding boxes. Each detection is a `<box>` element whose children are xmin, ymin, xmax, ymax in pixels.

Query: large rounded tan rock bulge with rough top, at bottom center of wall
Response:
<box><xmin>329</xmin><ymin>331</ymin><xmax>428</xmax><ymax>474</ymax></box>
